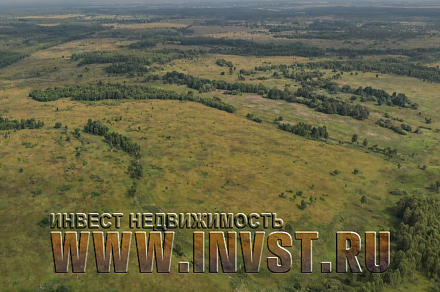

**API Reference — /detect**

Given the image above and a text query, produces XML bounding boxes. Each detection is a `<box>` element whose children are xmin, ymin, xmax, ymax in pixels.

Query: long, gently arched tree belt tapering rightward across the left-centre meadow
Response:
<box><xmin>29</xmin><ymin>82</ymin><xmax>235</xmax><ymax>113</ymax></box>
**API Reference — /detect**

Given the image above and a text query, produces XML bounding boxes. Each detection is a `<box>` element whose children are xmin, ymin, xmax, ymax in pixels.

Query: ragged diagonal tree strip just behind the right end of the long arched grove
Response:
<box><xmin>162</xmin><ymin>71</ymin><xmax>370</xmax><ymax>120</ymax></box>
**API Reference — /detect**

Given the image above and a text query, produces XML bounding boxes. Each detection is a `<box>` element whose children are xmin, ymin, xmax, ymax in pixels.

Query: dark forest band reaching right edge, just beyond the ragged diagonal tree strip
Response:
<box><xmin>307</xmin><ymin>58</ymin><xmax>440</xmax><ymax>83</ymax></box>
